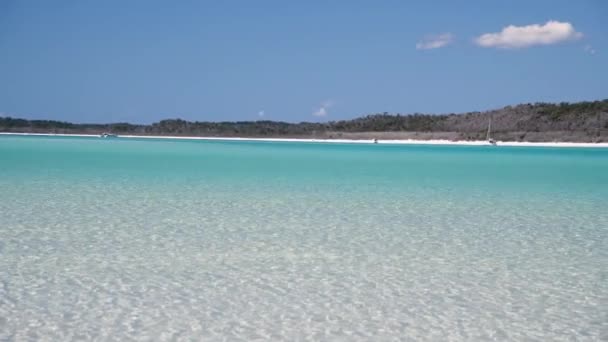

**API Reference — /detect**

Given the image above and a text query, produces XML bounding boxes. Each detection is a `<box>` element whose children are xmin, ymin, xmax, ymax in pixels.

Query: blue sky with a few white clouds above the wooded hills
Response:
<box><xmin>0</xmin><ymin>0</ymin><xmax>608</xmax><ymax>123</ymax></box>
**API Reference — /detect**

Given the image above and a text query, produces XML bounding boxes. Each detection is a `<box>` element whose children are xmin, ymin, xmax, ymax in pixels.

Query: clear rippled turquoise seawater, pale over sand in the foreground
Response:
<box><xmin>0</xmin><ymin>136</ymin><xmax>608</xmax><ymax>341</ymax></box>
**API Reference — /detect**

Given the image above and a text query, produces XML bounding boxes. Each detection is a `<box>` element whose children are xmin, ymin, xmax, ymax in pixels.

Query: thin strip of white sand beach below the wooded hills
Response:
<box><xmin>0</xmin><ymin>132</ymin><xmax>608</xmax><ymax>148</ymax></box>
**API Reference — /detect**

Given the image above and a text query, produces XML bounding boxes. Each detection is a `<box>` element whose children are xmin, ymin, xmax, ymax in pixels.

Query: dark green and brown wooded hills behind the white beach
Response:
<box><xmin>0</xmin><ymin>99</ymin><xmax>608</xmax><ymax>141</ymax></box>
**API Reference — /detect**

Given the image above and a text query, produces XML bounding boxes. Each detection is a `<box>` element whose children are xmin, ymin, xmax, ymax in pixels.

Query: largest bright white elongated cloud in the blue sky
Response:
<box><xmin>475</xmin><ymin>20</ymin><xmax>583</xmax><ymax>49</ymax></box>
